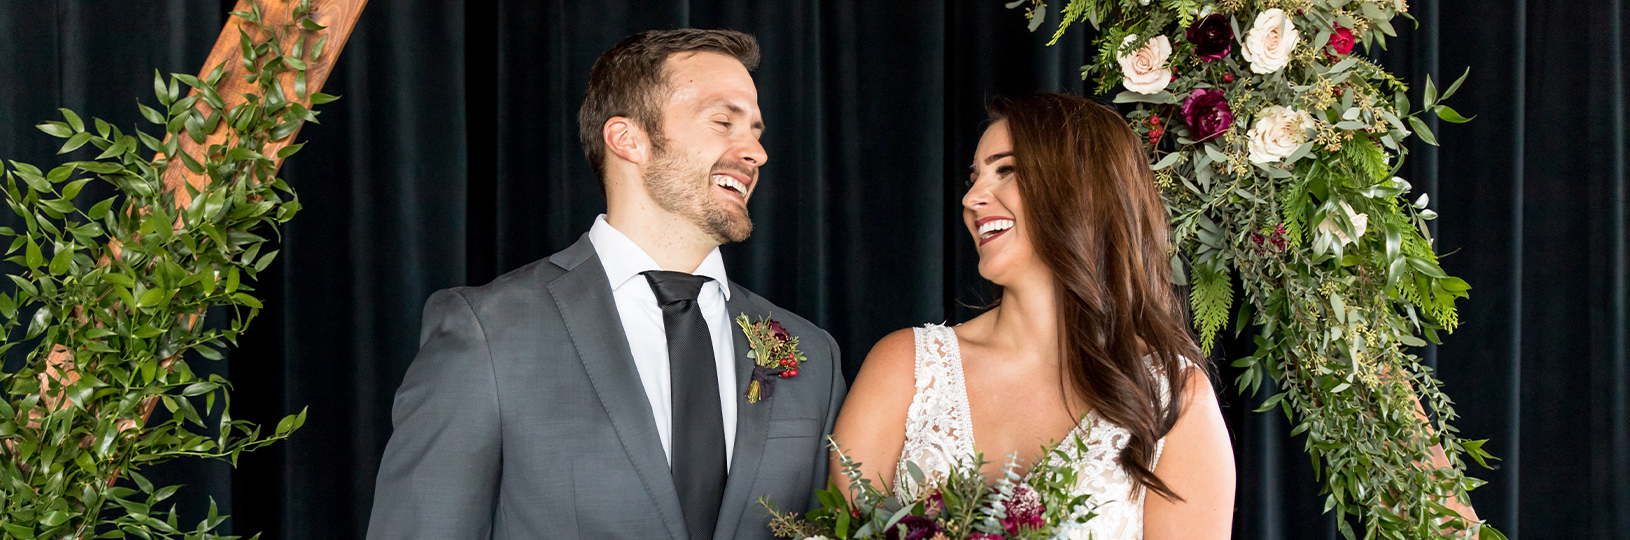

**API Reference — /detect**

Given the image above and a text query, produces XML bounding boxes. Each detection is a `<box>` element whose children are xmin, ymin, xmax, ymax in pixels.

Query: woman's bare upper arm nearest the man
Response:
<box><xmin>830</xmin><ymin>328</ymin><xmax>916</xmax><ymax>494</ymax></box>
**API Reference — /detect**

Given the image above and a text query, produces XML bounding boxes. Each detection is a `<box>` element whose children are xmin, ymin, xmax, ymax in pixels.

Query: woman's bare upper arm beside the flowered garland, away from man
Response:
<box><xmin>1143</xmin><ymin>369</ymin><xmax>1234</xmax><ymax>540</ymax></box>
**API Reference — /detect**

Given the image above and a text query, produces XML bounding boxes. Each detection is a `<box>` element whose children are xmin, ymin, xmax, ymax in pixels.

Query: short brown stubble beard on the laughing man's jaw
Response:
<box><xmin>644</xmin><ymin>147</ymin><xmax>753</xmax><ymax>243</ymax></box>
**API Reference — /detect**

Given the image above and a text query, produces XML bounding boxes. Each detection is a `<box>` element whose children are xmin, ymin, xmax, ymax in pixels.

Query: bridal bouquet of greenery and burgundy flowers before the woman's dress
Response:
<box><xmin>760</xmin><ymin>437</ymin><xmax>1095</xmax><ymax>540</ymax></box>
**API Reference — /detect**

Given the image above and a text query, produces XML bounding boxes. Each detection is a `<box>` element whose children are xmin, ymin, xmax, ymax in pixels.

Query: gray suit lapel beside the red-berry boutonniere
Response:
<box><xmin>714</xmin><ymin>284</ymin><xmax>776</xmax><ymax>538</ymax></box>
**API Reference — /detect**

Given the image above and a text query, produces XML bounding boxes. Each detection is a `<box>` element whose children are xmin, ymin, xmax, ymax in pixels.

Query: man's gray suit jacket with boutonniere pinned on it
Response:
<box><xmin>368</xmin><ymin>235</ymin><xmax>844</xmax><ymax>540</ymax></box>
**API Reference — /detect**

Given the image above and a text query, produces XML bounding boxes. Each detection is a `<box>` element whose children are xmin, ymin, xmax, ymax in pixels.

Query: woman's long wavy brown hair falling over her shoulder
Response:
<box><xmin>989</xmin><ymin>93</ymin><xmax>1201</xmax><ymax>501</ymax></box>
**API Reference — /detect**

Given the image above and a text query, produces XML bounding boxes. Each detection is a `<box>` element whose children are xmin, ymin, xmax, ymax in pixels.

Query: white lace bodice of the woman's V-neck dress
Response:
<box><xmin>895</xmin><ymin>325</ymin><xmax>1165</xmax><ymax>540</ymax></box>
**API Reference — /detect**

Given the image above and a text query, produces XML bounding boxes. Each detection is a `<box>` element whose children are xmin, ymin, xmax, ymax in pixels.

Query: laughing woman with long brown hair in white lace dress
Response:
<box><xmin>831</xmin><ymin>95</ymin><xmax>1234</xmax><ymax>540</ymax></box>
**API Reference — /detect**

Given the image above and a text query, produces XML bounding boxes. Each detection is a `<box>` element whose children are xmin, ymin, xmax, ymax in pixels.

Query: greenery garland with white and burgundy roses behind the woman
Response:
<box><xmin>1007</xmin><ymin>0</ymin><xmax>1500</xmax><ymax>538</ymax></box>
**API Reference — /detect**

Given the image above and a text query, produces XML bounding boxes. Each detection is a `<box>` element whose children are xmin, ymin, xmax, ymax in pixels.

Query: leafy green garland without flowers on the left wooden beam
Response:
<box><xmin>0</xmin><ymin>2</ymin><xmax>334</xmax><ymax>538</ymax></box>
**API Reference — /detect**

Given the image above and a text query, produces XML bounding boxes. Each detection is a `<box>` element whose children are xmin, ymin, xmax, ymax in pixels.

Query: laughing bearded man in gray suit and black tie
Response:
<box><xmin>368</xmin><ymin>29</ymin><xmax>844</xmax><ymax>540</ymax></box>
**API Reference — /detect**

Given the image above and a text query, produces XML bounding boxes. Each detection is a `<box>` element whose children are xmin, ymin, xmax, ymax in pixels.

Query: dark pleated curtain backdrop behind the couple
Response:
<box><xmin>0</xmin><ymin>0</ymin><xmax>1630</xmax><ymax>538</ymax></box>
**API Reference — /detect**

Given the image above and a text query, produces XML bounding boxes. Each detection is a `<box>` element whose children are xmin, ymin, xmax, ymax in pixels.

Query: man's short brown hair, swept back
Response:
<box><xmin>577</xmin><ymin>28</ymin><xmax>758</xmax><ymax>186</ymax></box>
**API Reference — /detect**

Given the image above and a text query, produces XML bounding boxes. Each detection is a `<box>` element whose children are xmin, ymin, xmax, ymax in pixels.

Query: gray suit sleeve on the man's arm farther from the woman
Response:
<box><xmin>368</xmin><ymin>290</ymin><xmax>502</xmax><ymax>540</ymax></box>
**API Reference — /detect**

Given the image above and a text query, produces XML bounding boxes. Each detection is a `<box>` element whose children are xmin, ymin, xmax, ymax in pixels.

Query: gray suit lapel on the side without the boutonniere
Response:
<box><xmin>549</xmin><ymin>235</ymin><xmax>685</xmax><ymax>538</ymax></box>
